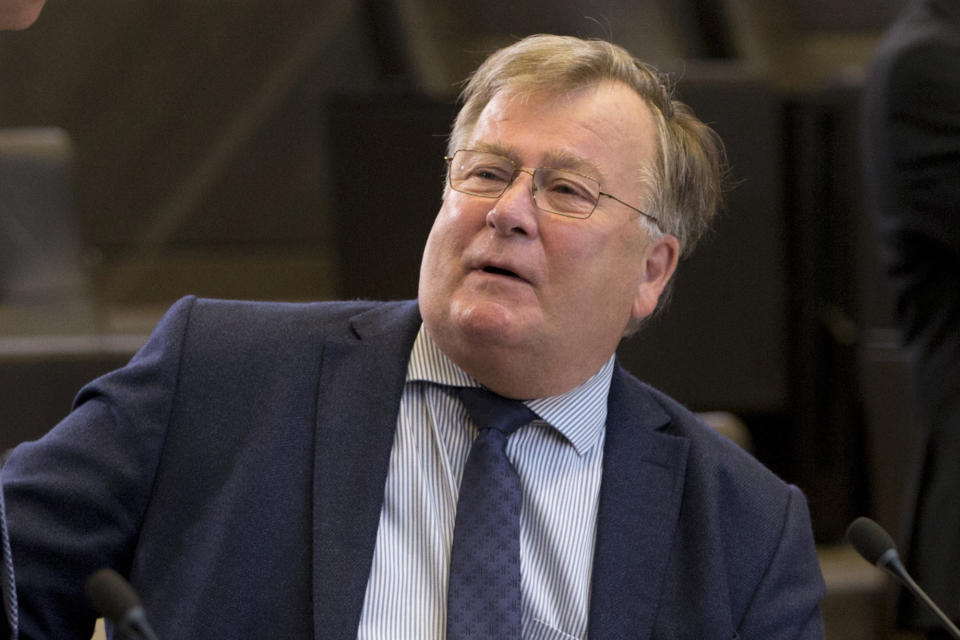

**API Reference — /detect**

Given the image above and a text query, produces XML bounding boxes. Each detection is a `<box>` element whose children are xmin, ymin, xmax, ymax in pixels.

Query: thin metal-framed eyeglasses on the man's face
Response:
<box><xmin>444</xmin><ymin>149</ymin><xmax>660</xmax><ymax>227</ymax></box>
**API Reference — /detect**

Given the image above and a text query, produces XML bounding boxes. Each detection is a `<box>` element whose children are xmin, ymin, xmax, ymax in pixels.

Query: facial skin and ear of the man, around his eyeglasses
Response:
<box><xmin>419</xmin><ymin>83</ymin><xmax>676</xmax><ymax>396</ymax></box>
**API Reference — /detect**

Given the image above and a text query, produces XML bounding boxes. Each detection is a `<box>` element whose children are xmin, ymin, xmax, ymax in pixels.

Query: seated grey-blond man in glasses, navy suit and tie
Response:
<box><xmin>5</xmin><ymin>36</ymin><xmax>824</xmax><ymax>640</ymax></box>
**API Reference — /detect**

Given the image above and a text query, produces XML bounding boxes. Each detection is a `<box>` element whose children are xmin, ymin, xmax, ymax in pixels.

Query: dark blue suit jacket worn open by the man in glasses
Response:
<box><xmin>4</xmin><ymin>298</ymin><xmax>824</xmax><ymax>640</ymax></box>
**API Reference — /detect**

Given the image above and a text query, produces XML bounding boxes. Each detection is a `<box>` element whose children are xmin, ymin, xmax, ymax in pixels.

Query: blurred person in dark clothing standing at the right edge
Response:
<box><xmin>864</xmin><ymin>0</ymin><xmax>960</xmax><ymax>639</ymax></box>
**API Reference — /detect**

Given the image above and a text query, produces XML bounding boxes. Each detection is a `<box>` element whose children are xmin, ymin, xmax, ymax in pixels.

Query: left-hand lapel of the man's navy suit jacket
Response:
<box><xmin>313</xmin><ymin>302</ymin><xmax>420</xmax><ymax>640</ymax></box>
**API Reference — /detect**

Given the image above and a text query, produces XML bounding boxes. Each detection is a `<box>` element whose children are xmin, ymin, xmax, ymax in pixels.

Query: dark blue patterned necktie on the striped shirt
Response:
<box><xmin>447</xmin><ymin>387</ymin><xmax>537</xmax><ymax>640</ymax></box>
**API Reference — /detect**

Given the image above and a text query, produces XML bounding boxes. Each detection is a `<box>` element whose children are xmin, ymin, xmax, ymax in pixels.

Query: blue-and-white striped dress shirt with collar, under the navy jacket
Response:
<box><xmin>358</xmin><ymin>327</ymin><xmax>613</xmax><ymax>640</ymax></box>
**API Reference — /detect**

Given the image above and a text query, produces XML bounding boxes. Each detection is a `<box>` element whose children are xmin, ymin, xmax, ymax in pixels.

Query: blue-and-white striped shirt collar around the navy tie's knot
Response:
<box><xmin>407</xmin><ymin>324</ymin><xmax>614</xmax><ymax>456</ymax></box>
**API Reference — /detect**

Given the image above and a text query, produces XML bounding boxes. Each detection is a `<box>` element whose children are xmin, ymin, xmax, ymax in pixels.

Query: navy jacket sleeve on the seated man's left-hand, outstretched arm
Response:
<box><xmin>3</xmin><ymin>299</ymin><xmax>193</xmax><ymax>640</ymax></box>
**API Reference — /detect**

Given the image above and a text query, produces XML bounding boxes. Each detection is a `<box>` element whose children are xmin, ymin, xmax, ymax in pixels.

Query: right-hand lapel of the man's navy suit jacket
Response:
<box><xmin>589</xmin><ymin>367</ymin><xmax>688</xmax><ymax>640</ymax></box>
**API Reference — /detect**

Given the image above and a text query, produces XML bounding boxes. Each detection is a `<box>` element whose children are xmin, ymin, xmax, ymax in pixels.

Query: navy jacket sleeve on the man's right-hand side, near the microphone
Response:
<box><xmin>739</xmin><ymin>486</ymin><xmax>826</xmax><ymax>640</ymax></box>
